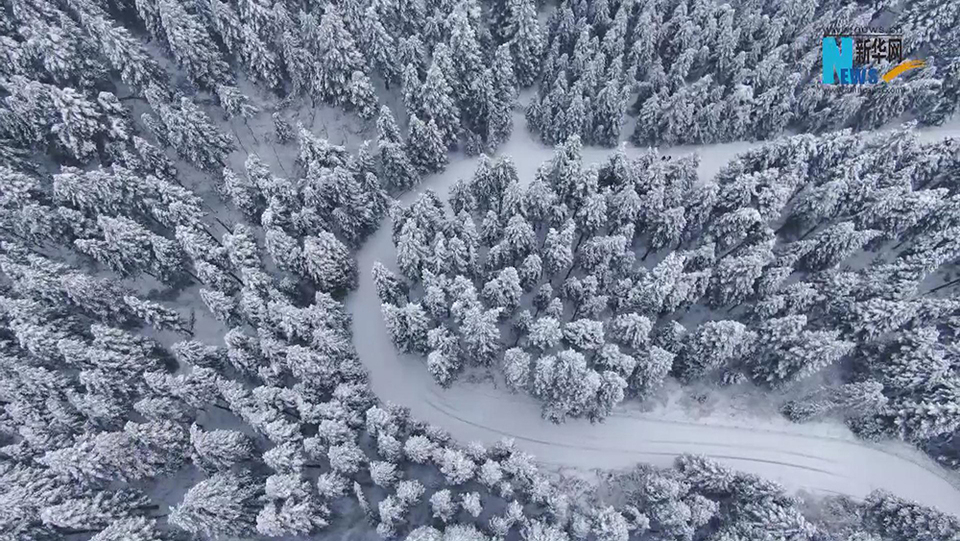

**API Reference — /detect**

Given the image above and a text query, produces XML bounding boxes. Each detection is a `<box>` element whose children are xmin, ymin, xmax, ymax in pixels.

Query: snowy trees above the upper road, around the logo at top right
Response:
<box><xmin>527</xmin><ymin>0</ymin><xmax>960</xmax><ymax>146</ymax></box>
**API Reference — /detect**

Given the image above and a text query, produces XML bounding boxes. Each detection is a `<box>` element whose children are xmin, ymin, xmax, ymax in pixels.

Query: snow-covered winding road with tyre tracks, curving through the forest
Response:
<box><xmin>347</xmin><ymin>114</ymin><xmax>960</xmax><ymax>515</ymax></box>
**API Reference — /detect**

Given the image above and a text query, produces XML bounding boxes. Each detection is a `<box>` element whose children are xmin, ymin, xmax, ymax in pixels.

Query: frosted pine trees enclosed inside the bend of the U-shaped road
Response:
<box><xmin>374</xmin><ymin>124</ymin><xmax>960</xmax><ymax>458</ymax></box>
